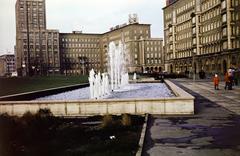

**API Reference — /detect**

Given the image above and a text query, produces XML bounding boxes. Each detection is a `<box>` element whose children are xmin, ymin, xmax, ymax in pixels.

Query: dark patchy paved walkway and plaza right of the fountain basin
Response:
<box><xmin>143</xmin><ymin>79</ymin><xmax>240</xmax><ymax>156</ymax></box>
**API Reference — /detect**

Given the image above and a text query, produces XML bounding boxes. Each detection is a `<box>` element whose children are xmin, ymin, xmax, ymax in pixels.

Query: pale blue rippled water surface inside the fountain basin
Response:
<box><xmin>34</xmin><ymin>83</ymin><xmax>175</xmax><ymax>101</ymax></box>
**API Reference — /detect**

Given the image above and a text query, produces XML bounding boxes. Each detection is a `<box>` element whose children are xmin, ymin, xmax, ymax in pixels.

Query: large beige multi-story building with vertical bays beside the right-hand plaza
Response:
<box><xmin>163</xmin><ymin>0</ymin><xmax>240</xmax><ymax>74</ymax></box>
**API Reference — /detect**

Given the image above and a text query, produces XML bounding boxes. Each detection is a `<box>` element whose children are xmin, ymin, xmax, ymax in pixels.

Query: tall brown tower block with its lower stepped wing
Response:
<box><xmin>15</xmin><ymin>0</ymin><xmax>60</xmax><ymax>75</ymax></box>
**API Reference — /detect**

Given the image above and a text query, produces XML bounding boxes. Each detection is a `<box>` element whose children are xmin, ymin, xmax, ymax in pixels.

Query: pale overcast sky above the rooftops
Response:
<box><xmin>0</xmin><ymin>0</ymin><xmax>165</xmax><ymax>54</ymax></box>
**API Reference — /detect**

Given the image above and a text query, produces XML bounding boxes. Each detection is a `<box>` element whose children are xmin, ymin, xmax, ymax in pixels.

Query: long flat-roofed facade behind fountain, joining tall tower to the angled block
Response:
<box><xmin>60</xmin><ymin>31</ymin><xmax>102</xmax><ymax>75</ymax></box>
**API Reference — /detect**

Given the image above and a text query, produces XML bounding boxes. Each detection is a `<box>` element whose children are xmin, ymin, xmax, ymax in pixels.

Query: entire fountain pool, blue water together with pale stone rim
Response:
<box><xmin>0</xmin><ymin>80</ymin><xmax>194</xmax><ymax>117</ymax></box>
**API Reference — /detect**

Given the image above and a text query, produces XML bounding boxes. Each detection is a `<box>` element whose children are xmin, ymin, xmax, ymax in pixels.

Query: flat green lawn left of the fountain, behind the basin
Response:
<box><xmin>0</xmin><ymin>75</ymin><xmax>88</xmax><ymax>96</ymax></box>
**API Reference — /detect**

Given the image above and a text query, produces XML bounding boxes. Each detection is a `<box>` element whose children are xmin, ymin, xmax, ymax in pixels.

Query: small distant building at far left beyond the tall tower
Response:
<box><xmin>0</xmin><ymin>54</ymin><xmax>16</xmax><ymax>76</ymax></box>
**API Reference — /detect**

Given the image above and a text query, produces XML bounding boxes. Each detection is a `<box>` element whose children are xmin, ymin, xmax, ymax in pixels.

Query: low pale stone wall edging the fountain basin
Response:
<box><xmin>0</xmin><ymin>81</ymin><xmax>194</xmax><ymax>116</ymax></box>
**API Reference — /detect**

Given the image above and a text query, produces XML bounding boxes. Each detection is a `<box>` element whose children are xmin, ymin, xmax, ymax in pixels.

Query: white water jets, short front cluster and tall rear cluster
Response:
<box><xmin>89</xmin><ymin>41</ymin><xmax>129</xmax><ymax>99</ymax></box>
